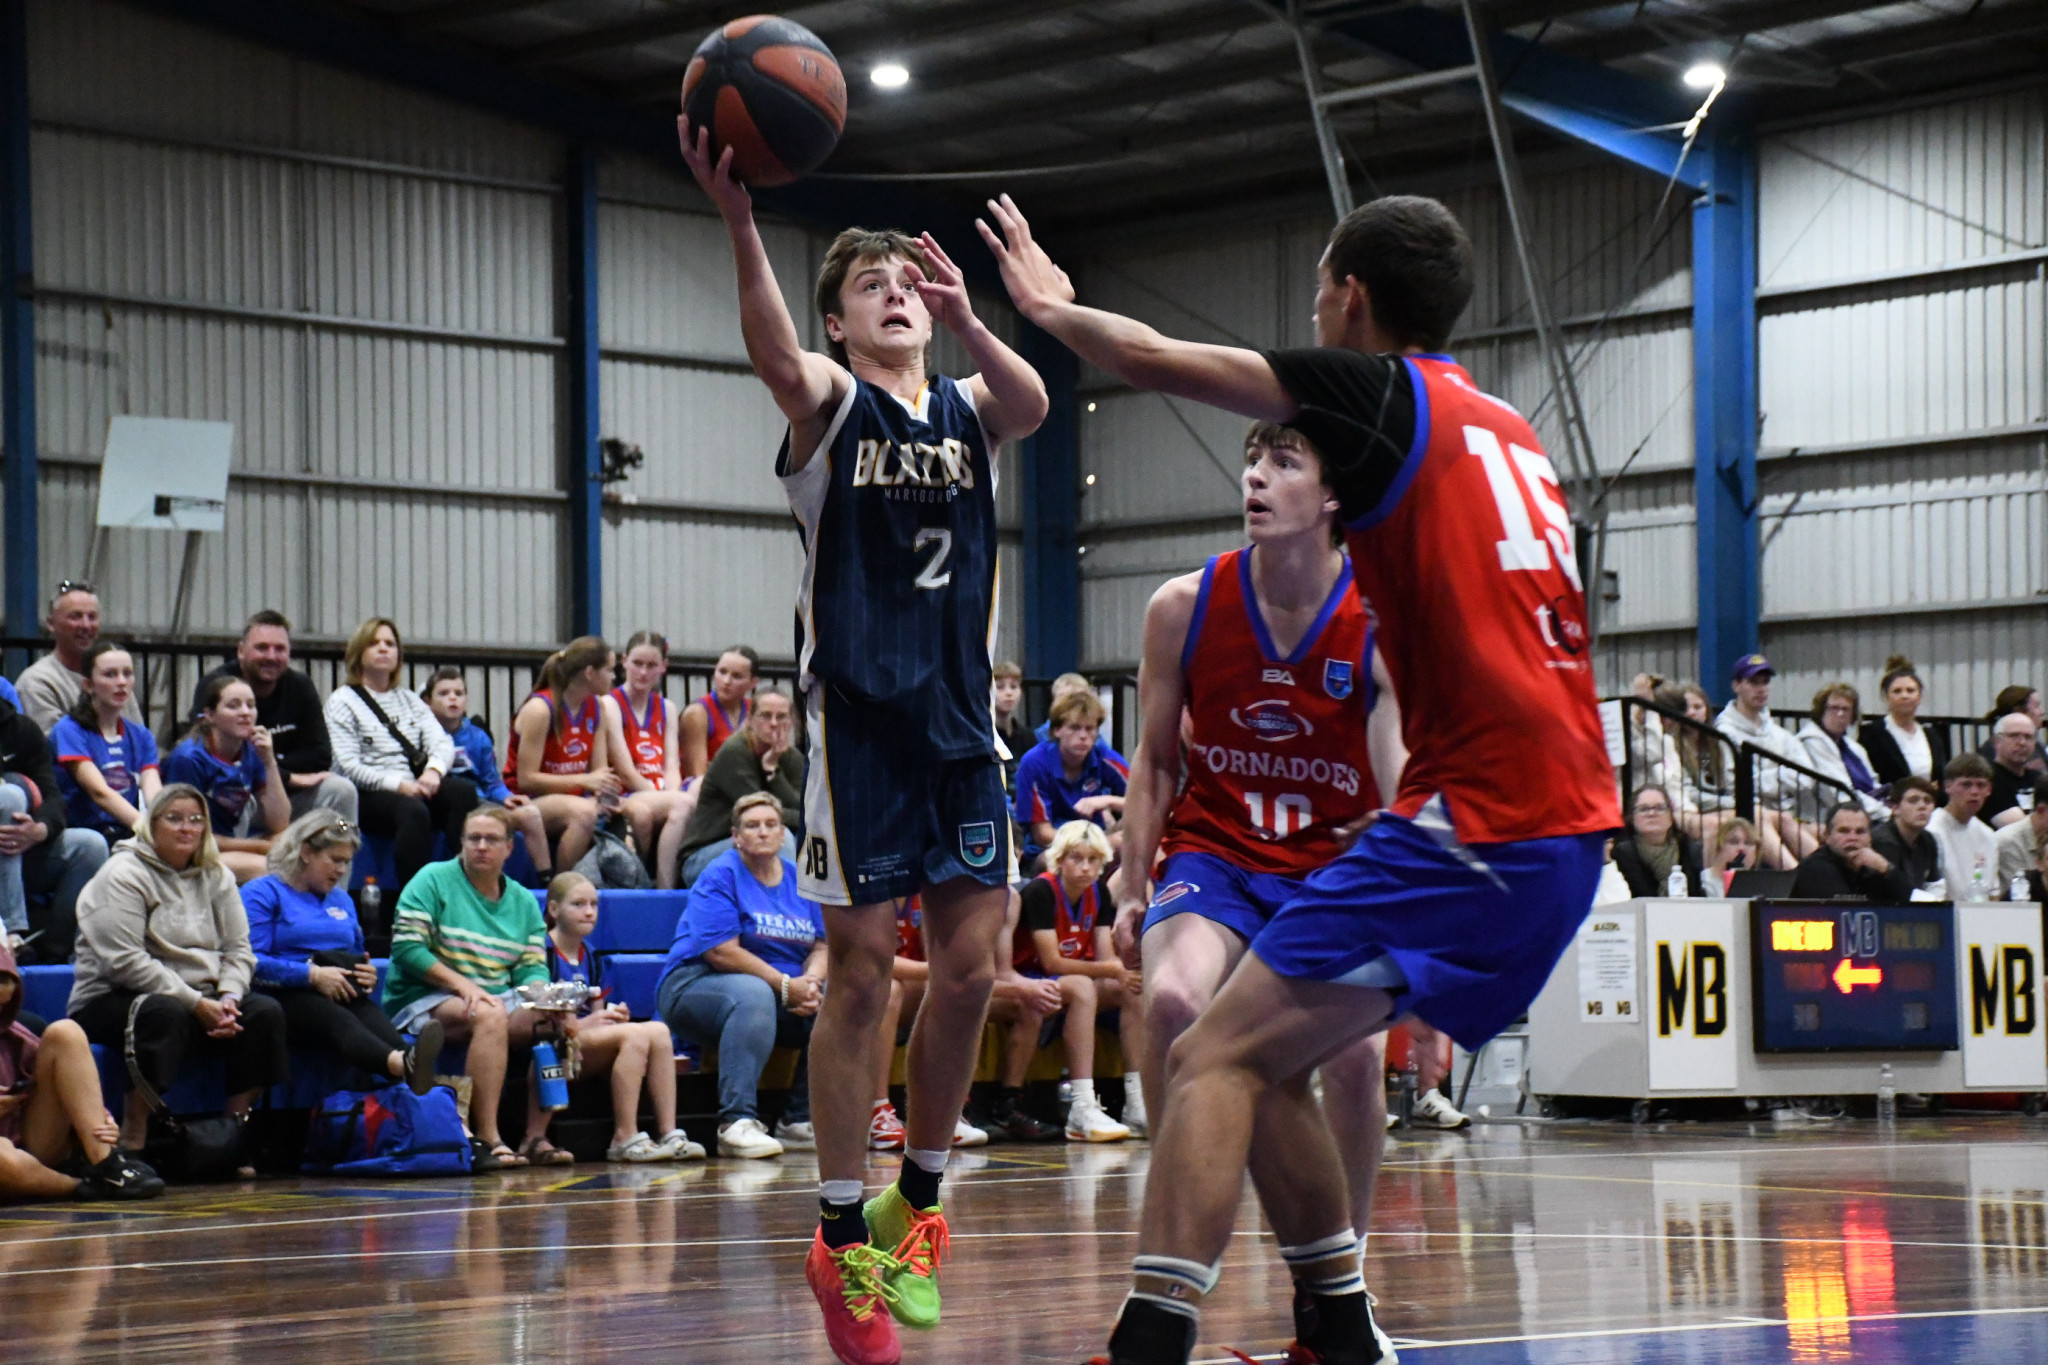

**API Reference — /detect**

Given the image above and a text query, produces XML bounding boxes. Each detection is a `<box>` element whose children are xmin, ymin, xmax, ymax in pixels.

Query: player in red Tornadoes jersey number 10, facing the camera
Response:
<box><xmin>1116</xmin><ymin>422</ymin><xmax>1407</xmax><ymax>1353</ymax></box>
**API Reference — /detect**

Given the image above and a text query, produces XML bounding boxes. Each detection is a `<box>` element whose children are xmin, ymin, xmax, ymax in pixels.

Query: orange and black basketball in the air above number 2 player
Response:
<box><xmin>682</xmin><ymin>14</ymin><xmax>846</xmax><ymax>188</ymax></box>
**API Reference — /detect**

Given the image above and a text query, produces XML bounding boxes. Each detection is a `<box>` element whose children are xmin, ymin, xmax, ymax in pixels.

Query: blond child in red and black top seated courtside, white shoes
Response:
<box><xmin>1004</xmin><ymin>822</ymin><xmax>1145</xmax><ymax>1142</ymax></box>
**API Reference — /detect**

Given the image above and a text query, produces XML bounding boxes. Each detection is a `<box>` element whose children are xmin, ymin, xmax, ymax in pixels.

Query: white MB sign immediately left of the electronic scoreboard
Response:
<box><xmin>1642</xmin><ymin>900</ymin><xmax>1749</xmax><ymax>1091</ymax></box>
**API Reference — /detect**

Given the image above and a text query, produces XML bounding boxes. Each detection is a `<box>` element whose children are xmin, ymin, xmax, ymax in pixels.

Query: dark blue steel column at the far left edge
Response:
<box><xmin>0</xmin><ymin>0</ymin><xmax>41</xmax><ymax>650</ymax></box>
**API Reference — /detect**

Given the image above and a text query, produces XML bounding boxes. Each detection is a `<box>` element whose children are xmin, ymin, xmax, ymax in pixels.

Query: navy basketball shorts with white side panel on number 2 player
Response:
<box><xmin>797</xmin><ymin>684</ymin><xmax>1016</xmax><ymax>905</ymax></box>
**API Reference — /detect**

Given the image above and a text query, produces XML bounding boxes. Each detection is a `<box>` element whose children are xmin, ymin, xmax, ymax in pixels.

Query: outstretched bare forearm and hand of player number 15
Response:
<box><xmin>975</xmin><ymin>194</ymin><xmax>1300</xmax><ymax>422</ymax></box>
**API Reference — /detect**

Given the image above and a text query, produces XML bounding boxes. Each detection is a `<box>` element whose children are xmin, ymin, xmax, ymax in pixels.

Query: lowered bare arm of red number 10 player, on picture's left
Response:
<box><xmin>1112</xmin><ymin>573</ymin><xmax>1202</xmax><ymax>964</ymax></box>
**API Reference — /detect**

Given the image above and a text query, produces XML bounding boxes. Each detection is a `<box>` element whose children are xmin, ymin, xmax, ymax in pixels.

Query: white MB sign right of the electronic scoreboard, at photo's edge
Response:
<box><xmin>1956</xmin><ymin>902</ymin><xmax>2048</xmax><ymax>1091</ymax></box>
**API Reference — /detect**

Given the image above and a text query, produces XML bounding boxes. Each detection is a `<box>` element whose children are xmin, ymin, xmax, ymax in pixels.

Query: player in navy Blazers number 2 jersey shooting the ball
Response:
<box><xmin>678</xmin><ymin>121</ymin><xmax>1047</xmax><ymax>1365</ymax></box>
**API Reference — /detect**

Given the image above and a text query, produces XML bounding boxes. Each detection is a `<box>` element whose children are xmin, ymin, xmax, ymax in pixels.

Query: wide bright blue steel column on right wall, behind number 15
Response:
<box><xmin>1692</xmin><ymin>133</ymin><xmax>1761</xmax><ymax>698</ymax></box>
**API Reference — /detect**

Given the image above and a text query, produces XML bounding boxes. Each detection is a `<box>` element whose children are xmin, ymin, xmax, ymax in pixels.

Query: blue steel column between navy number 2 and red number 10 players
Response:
<box><xmin>1020</xmin><ymin>323</ymin><xmax>1081</xmax><ymax>677</ymax></box>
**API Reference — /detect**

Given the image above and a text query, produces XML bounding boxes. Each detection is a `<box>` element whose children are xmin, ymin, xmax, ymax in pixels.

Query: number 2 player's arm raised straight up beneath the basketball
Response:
<box><xmin>676</xmin><ymin>119</ymin><xmax>852</xmax><ymax>444</ymax></box>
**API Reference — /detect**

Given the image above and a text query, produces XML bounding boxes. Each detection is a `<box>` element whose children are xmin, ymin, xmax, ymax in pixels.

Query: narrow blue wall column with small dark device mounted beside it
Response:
<box><xmin>563</xmin><ymin>143</ymin><xmax>604</xmax><ymax>634</ymax></box>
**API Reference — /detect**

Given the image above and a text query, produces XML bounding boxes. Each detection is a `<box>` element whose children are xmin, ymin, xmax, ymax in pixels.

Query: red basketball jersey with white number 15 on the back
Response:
<box><xmin>1348</xmin><ymin>356</ymin><xmax>1622</xmax><ymax>843</ymax></box>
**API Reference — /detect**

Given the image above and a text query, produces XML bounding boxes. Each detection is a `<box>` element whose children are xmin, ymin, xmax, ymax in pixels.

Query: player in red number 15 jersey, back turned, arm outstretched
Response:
<box><xmin>981</xmin><ymin>196</ymin><xmax>1620</xmax><ymax>1365</ymax></box>
